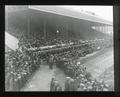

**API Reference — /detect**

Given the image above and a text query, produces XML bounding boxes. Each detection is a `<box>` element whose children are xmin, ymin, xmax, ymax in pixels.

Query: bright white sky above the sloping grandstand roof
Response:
<box><xmin>59</xmin><ymin>5</ymin><xmax>113</xmax><ymax>22</ymax></box>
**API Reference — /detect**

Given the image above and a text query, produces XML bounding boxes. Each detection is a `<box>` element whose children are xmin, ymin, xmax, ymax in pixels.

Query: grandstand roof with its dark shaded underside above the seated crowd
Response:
<box><xmin>6</xmin><ymin>6</ymin><xmax>113</xmax><ymax>40</ymax></box>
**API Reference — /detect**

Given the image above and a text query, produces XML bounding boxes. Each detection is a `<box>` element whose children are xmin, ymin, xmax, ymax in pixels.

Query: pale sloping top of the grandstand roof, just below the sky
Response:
<box><xmin>28</xmin><ymin>6</ymin><xmax>113</xmax><ymax>25</ymax></box>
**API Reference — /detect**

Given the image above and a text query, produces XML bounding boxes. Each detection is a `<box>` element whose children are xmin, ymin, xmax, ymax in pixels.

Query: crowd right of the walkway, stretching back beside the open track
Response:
<box><xmin>50</xmin><ymin>40</ymin><xmax>111</xmax><ymax>91</ymax></box>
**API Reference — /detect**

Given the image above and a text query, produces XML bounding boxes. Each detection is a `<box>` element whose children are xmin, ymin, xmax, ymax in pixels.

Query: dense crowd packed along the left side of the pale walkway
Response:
<box><xmin>5</xmin><ymin>50</ymin><xmax>41</xmax><ymax>91</ymax></box>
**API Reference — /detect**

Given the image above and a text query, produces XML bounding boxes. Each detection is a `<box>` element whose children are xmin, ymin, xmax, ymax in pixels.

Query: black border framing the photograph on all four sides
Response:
<box><xmin>0</xmin><ymin>0</ymin><xmax>120</xmax><ymax>96</ymax></box>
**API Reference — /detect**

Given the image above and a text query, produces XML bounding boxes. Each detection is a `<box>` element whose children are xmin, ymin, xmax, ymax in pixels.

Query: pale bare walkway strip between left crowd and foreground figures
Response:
<box><xmin>21</xmin><ymin>65</ymin><xmax>55</xmax><ymax>91</ymax></box>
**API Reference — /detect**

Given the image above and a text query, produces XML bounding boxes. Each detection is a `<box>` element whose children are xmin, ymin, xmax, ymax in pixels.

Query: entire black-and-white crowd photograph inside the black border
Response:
<box><xmin>5</xmin><ymin>5</ymin><xmax>115</xmax><ymax>92</ymax></box>
